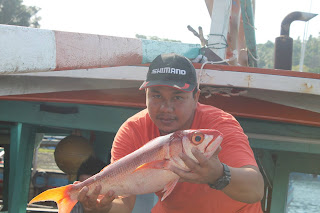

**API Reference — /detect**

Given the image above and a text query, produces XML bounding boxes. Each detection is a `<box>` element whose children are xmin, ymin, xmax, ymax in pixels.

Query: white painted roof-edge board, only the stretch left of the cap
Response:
<box><xmin>0</xmin><ymin>66</ymin><xmax>147</xmax><ymax>97</ymax></box>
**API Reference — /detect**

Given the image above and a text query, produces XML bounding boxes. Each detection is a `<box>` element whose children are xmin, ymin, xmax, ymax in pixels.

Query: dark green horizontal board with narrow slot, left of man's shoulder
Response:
<box><xmin>0</xmin><ymin>101</ymin><xmax>141</xmax><ymax>133</ymax></box>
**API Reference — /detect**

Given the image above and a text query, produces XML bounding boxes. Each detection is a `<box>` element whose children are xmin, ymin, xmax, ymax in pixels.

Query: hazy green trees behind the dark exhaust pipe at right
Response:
<box><xmin>257</xmin><ymin>33</ymin><xmax>320</xmax><ymax>74</ymax></box>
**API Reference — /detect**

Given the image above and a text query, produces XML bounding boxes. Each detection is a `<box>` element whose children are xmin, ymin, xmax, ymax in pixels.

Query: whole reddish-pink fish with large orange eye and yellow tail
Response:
<box><xmin>29</xmin><ymin>129</ymin><xmax>222</xmax><ymax>213</ymax></box>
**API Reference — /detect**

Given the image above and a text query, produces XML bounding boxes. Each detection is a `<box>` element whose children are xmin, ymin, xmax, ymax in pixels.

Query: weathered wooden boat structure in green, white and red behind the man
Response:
<box><xmin>0</xmin><ymin>0</ymin><xmax>320</xmax><ymax>213</ymax></box>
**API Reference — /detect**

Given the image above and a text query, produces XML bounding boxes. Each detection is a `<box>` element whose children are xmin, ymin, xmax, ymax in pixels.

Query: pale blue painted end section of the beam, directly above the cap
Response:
<box><xmin>142</xmin><ymin>39</ymin><xmax>201</xmax><ymax>64</ymax></box>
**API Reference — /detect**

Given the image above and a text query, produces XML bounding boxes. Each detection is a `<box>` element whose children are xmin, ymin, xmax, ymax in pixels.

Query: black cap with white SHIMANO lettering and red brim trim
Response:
<box><xmin>140</xmin><ymin>53</ymin><xmax>197</xmax><ymax>92</ymax></box>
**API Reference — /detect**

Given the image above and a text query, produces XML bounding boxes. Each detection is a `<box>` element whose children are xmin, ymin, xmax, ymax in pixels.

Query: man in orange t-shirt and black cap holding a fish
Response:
<box><xmin>79</xmin><ymin>54</ymin><xmax>264</xmax><ymax>213</ymax></box>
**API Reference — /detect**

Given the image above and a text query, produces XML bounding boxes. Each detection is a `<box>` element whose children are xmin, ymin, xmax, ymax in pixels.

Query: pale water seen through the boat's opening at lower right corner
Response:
<box><xmin>287</xmin><ymin>173</ymin><xmax>320</xmax><ymax>213</ymax></box>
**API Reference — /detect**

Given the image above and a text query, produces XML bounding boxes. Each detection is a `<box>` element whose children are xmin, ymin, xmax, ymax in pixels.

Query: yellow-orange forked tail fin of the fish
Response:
<box><xmin>29</xmin><ymin>185</ymin><xmax>78</xmax><ymax>213</ymax></box>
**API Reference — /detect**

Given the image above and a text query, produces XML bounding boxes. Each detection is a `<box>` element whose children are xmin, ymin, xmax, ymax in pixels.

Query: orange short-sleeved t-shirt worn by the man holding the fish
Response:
<box><xmin>111</xmin><ymin>103</ymin><xmax>262</xmax><ymax>213</ymax></box>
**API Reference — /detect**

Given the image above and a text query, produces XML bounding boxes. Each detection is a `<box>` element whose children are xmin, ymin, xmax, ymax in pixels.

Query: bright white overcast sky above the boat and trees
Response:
<box><xmin>23</xmin><ymin>0</ymin><xmax>320</xmax><ymax>44</ymax></box>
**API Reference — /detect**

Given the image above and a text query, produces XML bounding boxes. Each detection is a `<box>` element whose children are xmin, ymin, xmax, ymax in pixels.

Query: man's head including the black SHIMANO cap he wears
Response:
<box><xmin>140</xmin><ymin>54</ymin><xmax>200</xmax><ymax>135</ymax></box>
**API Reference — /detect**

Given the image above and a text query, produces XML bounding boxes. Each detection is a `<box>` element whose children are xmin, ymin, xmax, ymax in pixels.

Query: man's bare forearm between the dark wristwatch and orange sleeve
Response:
<box><xmin>222</xmin><ymin>166</ymin><xmax>264</xmax><ymax>203</ymax></box>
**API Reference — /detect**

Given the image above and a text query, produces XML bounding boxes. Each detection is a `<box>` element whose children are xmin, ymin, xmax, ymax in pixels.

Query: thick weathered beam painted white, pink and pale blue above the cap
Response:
<box><xmin>0</xmin><ymin>25</ymin><xmax>200</xmax><ymax>74</ymax></box>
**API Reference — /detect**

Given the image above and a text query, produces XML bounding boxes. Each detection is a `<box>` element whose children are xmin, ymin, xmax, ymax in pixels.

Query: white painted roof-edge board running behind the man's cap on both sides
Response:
<box><xmin>0</xmin><ymin>64</ymin><xmax>320</xmax><ymax>95</ymax></box>
